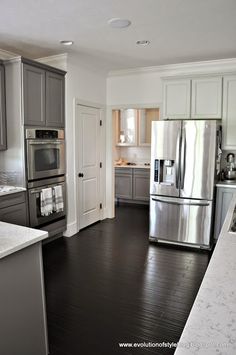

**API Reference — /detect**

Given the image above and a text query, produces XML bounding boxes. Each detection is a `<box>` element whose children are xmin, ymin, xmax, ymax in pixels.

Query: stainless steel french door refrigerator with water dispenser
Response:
<box><xmin>149</xmin><ymin>120</ymin><xmax>220</xmax><ymax>249</ymax></box>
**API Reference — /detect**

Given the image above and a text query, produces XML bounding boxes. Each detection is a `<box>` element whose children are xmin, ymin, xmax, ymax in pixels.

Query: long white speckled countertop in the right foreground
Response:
<box><xmin>175</xmin><ymin>194</ymin><xmax>236</xmax><ymax>355</ymax></box>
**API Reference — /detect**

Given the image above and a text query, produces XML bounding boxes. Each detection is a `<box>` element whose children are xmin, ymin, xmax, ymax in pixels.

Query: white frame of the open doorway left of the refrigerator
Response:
<box><xmin>106</xmin><ymin>102</ymin><xmax>162</xmax><ymax>218</ymax></box>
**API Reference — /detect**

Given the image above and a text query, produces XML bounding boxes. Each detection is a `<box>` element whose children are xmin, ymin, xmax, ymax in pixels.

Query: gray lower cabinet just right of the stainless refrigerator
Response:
<box><xmin>214</xmin><ymin>187</ymin><xmax>236</xmax><ymax>239</ymax></box>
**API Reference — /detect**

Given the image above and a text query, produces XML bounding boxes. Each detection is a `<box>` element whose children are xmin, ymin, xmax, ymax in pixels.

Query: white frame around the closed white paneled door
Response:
<box><xmin>73</xmin><ymin>98</ymin><xmax>106</xmax><ymax>232</ymax></box>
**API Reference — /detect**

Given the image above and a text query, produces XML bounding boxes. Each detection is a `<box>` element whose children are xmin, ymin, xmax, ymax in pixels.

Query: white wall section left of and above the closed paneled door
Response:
<box><xmin>40</xmin><ymin>55</ymin><xmax>106</xmax><ymax>236</ymax></box>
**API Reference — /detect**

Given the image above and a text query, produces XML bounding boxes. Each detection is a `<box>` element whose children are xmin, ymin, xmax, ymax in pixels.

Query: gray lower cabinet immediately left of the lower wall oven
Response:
<box><xmin>0</xmin><ymin>192</ymin><xmax>28</xmax><ymax>226</ymax></box>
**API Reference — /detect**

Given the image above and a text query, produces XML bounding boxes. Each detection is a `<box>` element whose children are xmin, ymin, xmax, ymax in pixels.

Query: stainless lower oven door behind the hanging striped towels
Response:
<box><xmin>28</xmin><ymin>182</ymin><xmax>66</xmax><ymax>227</ymax></box>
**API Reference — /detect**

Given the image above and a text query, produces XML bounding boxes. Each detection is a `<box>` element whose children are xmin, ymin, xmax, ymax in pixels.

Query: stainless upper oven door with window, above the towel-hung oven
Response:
<box><xmin>27</xmin><ymin>139</ymin><xmax>65</xmax><ymax>180</ymax></box>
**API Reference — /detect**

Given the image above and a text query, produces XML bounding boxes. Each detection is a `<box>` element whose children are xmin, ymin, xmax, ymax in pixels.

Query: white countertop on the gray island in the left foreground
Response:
<box><xmin>0</xmin><ymin>222</ymin><xmax>48</xmax><ymax>259</ymax></box>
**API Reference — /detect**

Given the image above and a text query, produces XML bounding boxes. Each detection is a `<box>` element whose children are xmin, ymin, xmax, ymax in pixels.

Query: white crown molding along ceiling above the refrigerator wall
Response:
<box><xmin>108</xmin><ymin>58</ymin><xmax>236</xmax><ymax>77</ymax></box>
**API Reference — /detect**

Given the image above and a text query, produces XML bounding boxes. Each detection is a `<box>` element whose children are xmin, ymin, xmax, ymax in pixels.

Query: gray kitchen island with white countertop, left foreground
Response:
<box><xmin>0</xmin><ymin>222</ymin><xmax>48</xmax><ymax>355</ymax></box>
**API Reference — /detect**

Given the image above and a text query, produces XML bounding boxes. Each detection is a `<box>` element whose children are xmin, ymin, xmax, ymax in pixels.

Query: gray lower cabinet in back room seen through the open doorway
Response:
<box><xmin>115</xmin><ymin>168</ymin><xmax>150</xmax><ymax>203</ymax></box>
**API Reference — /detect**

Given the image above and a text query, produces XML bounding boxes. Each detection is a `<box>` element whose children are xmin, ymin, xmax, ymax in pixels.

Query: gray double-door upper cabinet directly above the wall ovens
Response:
<box><xmin>23</xmin><ymin>63</ymin><xmax>65</xmax><ymax>128</ymax></box>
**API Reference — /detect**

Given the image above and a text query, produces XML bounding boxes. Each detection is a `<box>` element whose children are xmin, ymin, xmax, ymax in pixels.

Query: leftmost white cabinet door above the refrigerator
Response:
<box><xmin>163</xmin><ymin>79</ymin><xmax>191</xmax><ymax>119</ymax></box>
